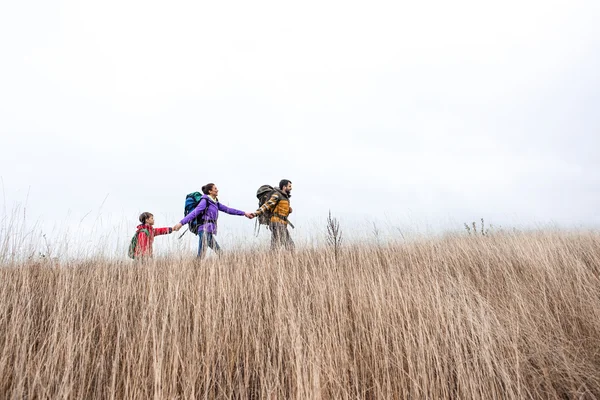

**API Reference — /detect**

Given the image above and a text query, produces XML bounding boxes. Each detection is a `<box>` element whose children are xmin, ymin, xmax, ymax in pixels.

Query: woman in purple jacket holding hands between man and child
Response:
<box><xmin>173</xmin><ymin>183</ymin><xmax>254</xmax><ymax>257</ymax></box>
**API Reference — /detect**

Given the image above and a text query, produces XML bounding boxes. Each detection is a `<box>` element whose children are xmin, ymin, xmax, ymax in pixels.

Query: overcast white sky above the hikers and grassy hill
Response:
<box><xmin>0</xmin><ymin>0</ymin><xmax>600</xmax><ymax>253</ymax></box>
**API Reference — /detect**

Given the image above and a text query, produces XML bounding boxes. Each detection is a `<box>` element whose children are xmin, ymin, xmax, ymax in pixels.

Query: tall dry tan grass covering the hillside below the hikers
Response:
<box><xmin>0</xmin><ymin>232</ymin><xmax>600</xmax><ymax>399</ymax></box>
